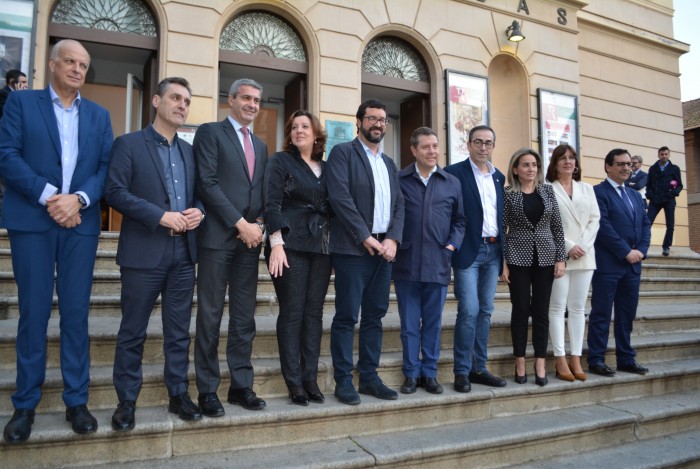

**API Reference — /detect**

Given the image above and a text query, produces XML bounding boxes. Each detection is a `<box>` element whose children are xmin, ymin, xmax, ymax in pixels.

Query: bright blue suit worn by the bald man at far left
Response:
<box><xmin>0</xmin><ymin>88</ymin><xmax>113</xmax><ymax>409</ymax></box>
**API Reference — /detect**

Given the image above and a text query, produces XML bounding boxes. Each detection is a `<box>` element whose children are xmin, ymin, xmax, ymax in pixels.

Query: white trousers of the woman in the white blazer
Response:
<box><xmin>549</xmin><ymin>270</ymin><xmax>593</xmax><ymax>357</ymax></box>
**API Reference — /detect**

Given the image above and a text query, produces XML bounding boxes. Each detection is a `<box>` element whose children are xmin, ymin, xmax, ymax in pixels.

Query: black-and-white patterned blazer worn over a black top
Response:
<box><xmin>503</xmin><ymin>184</ymin><xmax>566</xmax><ymax>267</ymax></box>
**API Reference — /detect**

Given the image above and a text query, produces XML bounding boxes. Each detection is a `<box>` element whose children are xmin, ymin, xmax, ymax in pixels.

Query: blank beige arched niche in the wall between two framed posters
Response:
<box><xmin>489</xmin><ymin>54</ymin><xmax>528</xmax><ymax>170</ymax></box>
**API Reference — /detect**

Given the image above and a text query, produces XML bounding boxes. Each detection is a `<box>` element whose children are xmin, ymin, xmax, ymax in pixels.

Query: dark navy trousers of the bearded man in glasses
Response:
<box><xmin>331</xmin><ymin>254</ymin><xmax>391</xmax><ymax>383</ymax></box>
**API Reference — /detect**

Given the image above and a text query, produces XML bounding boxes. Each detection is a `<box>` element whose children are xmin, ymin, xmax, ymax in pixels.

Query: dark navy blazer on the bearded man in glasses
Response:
<box><xmin>327</xmin><ymin>138</ymin><xmax>404</xmax><ymax>256</ymax></box>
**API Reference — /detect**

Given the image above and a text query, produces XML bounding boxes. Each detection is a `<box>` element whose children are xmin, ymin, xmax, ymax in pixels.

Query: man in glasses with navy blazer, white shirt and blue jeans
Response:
<box><xmin>445</xmin><ymin>125</ymin><xmax>506</xmax><ymax>392</ymax></box>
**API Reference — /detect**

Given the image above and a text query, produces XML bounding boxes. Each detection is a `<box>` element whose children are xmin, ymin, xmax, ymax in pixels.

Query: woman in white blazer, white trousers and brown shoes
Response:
<box><xmin>546</xmin><ymin>145</ymin><xmax>600</xmax><ymax>381</ymax></box>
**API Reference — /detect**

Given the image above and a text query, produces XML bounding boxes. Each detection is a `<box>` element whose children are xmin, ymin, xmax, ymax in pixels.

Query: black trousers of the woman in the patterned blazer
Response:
<box><xmin>508</xmin><ymin>264</ymin><xmax>554</xmax><ymax>358</ymax></box>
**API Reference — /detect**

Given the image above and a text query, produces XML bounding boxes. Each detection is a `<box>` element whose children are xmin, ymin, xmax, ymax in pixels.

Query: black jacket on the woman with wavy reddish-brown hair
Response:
<box><xmin>265</xmin><ymin>151</ymin><xmax>331</xmax><ymax>254</ymax></box>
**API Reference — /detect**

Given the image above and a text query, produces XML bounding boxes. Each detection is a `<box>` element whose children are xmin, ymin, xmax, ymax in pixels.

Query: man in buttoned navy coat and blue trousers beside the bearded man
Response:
<box><xmin>392</xmin><ymin>127</ymin><xmax>466</xmax><ymax>394</ymax></box>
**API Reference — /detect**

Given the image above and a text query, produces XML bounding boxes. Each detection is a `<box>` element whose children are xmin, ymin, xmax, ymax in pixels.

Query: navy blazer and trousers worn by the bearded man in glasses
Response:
<box><xmin>326</xmin><ymin>138</ymin><xmax>404</xmax><ymax>384</ymax></box>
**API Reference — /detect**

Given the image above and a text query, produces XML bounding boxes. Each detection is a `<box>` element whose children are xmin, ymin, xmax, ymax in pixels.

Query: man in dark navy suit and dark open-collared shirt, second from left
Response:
<box><xmin>105</xmin><ymin>77</ymin><xmax>204</xmax><ymax>431</ymax></box>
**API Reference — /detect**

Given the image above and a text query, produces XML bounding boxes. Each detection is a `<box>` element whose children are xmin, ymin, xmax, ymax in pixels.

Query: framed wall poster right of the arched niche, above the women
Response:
<box><xmin>537</xmin><ymin>88</ymin><xmax>580</xmax><ymax>168</ymax></box>
